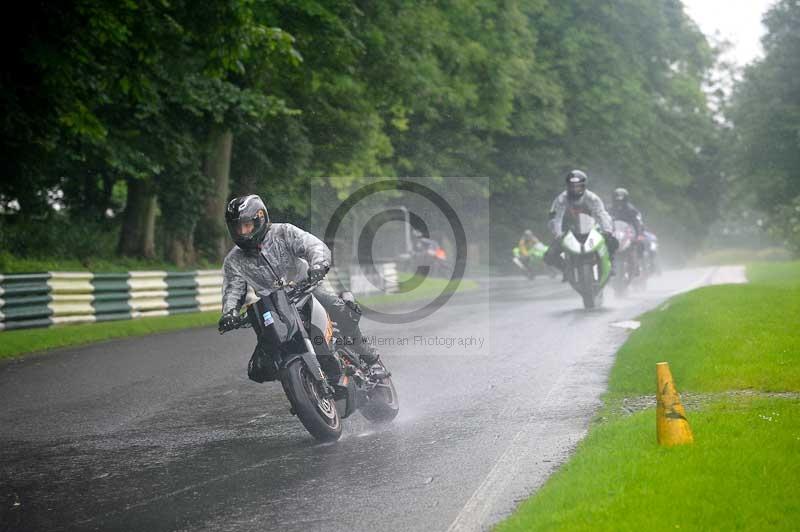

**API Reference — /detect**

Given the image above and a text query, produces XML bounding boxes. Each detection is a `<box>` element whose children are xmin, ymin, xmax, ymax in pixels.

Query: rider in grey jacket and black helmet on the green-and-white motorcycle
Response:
<box><xmin>544</xmin><ymin>170</ymin><xmax>619</xmax><ymax>280</ymax></box>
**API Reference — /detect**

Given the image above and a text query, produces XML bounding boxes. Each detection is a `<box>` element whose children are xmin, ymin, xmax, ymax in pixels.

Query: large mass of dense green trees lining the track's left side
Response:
<box><xmin>0</xmin><ymin>0</ymin><xmax>719</xmax><ymax>263</ymax></box>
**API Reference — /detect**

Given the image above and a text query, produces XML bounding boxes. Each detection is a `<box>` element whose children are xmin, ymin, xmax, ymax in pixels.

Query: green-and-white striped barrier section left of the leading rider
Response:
<box><xmin>0</xmin><ymin>270</ymin><xmax>222</xmax><ymax>331</ymax></box>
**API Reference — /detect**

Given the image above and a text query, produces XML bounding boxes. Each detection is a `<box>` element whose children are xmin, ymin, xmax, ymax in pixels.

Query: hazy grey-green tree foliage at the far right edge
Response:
<box><xmin>728</xmin><ymin>0</ymin><xmax>800</xmax><ymax>253</ymax></box>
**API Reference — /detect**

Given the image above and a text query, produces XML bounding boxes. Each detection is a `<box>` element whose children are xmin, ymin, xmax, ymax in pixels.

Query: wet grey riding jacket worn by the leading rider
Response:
<box><xmin>222</xmin><ymin>224</ymin><xmax>331</xmax><ymax>313</ymax></box>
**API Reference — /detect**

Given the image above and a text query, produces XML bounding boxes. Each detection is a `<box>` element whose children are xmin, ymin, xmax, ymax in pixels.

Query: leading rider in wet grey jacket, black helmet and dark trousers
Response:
<box><xmin>219</xmin><ymin>194</ymin><xmax>378</xmax><ymax>364</ymax></box>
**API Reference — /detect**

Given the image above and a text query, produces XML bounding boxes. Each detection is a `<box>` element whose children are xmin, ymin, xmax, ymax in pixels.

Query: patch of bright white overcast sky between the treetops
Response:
<box><xmin>680</xmin><ymin>0</ymin><xmax>774</xmax><ymax>66</ymax></box>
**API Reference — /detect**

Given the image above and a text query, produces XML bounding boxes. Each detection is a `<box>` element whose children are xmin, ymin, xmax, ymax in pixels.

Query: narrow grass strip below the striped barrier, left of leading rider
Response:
<box><xmin>0</xmin><ymin>312</ymin><xmax>219</xmax><ymax>359</ymax></box>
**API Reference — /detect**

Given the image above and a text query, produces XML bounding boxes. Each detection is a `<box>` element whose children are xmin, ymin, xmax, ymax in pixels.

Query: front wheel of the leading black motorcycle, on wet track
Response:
<box><xmin>281</xmin><ymin>359</ymin><xmax>342</xmax><ymax>442</ymax></box>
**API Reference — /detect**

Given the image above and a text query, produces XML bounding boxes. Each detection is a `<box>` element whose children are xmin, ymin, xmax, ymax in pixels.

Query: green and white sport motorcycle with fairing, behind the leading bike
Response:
<box><xmin>561</xmin><ymin>213</ymin><xmax>611</xmax><ymax>309</ymax></box>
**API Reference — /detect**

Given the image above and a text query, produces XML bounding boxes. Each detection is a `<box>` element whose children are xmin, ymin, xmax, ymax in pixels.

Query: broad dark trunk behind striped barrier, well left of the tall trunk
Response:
<box><xmin>117</xmin><ymin>179</ymin><xmax>156</xmax><ymax>259</ymax></box>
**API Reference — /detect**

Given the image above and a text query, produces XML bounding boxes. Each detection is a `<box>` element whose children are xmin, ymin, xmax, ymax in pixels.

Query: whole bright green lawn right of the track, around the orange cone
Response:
<box><xmin>497</xmin><ymin>262</ymin><xmax>800</xmax><ymax>531</ymax></box>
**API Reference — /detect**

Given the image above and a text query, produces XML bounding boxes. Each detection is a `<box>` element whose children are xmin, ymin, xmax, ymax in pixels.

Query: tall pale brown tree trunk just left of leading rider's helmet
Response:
<box><xmin>198</xmin><ymin>125</ymin><xmax>233</xmax><ymax>262</ymax></box>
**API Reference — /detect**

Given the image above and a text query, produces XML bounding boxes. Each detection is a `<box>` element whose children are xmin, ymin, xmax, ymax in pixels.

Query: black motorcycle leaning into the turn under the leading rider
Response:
<box><xmin>222</xmin><ymin>281</ymin><xmax>399</xmax><ymax>442</ymax></box>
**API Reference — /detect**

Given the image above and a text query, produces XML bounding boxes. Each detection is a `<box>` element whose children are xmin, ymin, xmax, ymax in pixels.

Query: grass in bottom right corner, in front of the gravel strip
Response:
<box><xmin>497</xmin><ymin>399</ymin><xmax>800</xmax><ymax>532</ymax></box>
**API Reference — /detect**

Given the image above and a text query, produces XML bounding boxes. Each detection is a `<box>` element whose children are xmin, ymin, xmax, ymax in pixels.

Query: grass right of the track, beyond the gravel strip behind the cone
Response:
<box><xmin>609</xmin><ymin>274</ymin><xmax>800</xmax><ymax>395</ymax></box>
